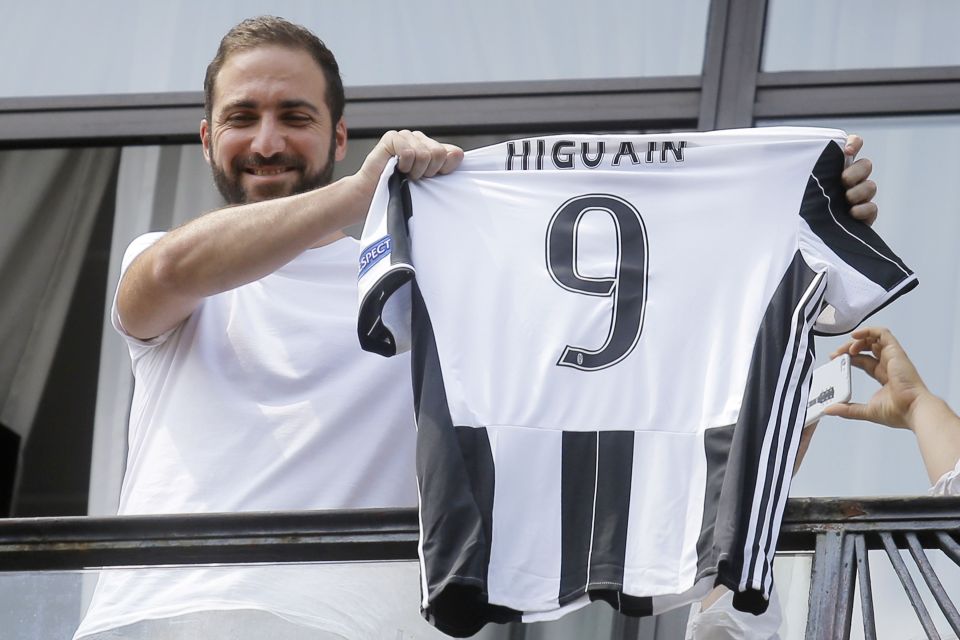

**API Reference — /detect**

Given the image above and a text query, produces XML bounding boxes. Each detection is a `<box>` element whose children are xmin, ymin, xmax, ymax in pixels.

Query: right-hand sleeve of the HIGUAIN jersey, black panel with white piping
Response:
<box><xmin>798</xmin><ymin>141</ymin><xmax>917</xmax><ymax>335</ymax></box>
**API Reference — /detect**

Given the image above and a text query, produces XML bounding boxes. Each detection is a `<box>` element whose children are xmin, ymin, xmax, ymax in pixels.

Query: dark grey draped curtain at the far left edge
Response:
<box><xmin>0</xmin><ymin>149</ymin><xmax>117</xmax><ymax>464</ymax></box>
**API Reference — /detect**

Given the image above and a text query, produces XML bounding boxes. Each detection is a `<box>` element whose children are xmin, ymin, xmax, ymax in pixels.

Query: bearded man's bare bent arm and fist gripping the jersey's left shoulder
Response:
<box><xmin>117</xmin><ymin>131</ymin><xmax>463</xmax><ymax>339</ymax></box>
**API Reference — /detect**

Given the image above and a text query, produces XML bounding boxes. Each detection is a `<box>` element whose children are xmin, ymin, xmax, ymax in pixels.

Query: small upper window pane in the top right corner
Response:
<box><xmin>761</xmin><ymin>0</ymin><xmax>960</xmax><ymax>71</ymax></box>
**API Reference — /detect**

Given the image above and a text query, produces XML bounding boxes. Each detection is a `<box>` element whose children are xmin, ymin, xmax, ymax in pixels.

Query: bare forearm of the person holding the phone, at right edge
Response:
<box><xmin>908</xmin><ymin>392</ymin><xmax>960</xmax><ymax>483</ymax></box>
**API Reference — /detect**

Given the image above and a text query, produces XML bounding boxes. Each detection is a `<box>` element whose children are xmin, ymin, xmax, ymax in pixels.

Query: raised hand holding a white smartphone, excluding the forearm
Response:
<box><xmin>826</xmin><ymin>327</ymin><xmax>930</xmax><ymax>429</ymax></box>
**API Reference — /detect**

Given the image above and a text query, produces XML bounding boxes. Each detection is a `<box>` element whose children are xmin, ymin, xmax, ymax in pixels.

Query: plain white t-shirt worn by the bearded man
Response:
<box><xmin>78</xmin><ymin>234</ymin><xmax>446</xmax><ymax>640</ymax></box>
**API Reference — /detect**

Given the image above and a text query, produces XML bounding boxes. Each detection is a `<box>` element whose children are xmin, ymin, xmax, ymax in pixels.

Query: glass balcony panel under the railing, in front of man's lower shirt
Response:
<box><xmin>15</xmin><ymin>562</ymin><xmax>438</xmax><ymax>640</ymax></box>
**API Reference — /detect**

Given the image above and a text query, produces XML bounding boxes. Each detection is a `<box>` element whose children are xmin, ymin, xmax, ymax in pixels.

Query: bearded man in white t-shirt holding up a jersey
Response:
<box><xmin>78</xmin><ymin>17</ymin><xmax>876</xmax><ymax>640</ymax></box>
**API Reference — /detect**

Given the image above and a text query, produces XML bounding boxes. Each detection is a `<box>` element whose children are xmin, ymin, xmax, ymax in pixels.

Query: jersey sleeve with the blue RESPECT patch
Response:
<box><xmin>357</xmin><ymin>160</ymin><xmax>415</xmax><ymax>357</ymax></box>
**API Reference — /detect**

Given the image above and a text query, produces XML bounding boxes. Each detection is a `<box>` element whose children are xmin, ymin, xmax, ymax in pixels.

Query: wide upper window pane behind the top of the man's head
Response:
<box><xmin>0</xmin><ymin>0</ymin><xmax>709</xmax><ymax>96</ymax></box>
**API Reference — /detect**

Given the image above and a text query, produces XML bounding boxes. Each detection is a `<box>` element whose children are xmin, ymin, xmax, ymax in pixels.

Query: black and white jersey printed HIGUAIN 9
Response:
<box><xmin>359</xmin><ymin>128</ymin><xmax>917</xmax><ymax>636</ymax></box>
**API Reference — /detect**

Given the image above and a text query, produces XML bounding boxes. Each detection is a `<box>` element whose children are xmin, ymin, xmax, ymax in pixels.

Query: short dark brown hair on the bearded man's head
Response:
<box><xmin>203</xmin><ymin>16</ymin><xmax>344</xmax><ymax>124</ymax></box>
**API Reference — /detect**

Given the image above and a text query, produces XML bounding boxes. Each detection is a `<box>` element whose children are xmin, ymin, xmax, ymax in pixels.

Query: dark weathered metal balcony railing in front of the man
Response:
<box><xmin>0</xmin><ymin>496</ymin><xmax>960</xmax><ymax>640</ymax></box>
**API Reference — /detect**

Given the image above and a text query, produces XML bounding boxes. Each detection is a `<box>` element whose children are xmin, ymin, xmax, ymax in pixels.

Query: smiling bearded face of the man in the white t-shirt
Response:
<box><xmin>200</xmin><ymin>46</ymin><xmax>347</xmax><ymax>204</ymax></box>
